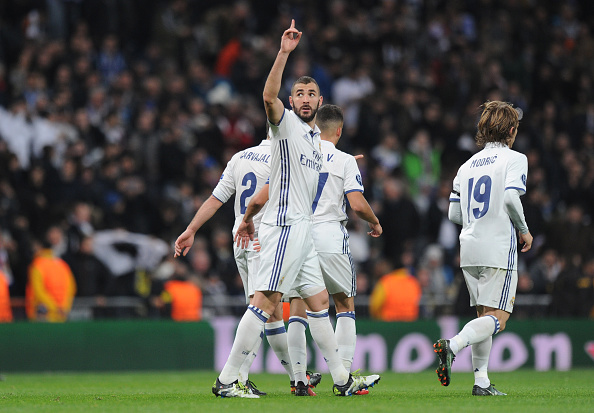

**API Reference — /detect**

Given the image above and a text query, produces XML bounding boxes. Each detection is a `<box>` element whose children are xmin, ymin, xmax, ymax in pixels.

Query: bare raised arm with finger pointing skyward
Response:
<box><xmin>262</xmin><ymin>20</ymin><xmax>302</xmax><ymax>125</ymax></box>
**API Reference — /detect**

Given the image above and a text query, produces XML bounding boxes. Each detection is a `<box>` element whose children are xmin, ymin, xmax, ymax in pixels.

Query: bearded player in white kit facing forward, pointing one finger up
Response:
<box><xmin>212</xmin><ymin>20</ymin><xmax>380</xmax><ymax>397</ymax></box>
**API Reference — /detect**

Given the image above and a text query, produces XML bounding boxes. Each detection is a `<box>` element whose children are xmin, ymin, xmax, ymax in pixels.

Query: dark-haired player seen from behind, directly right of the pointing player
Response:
<box><xmin>246</xmin><ymin>104</ymin><xmax>382</xmax><ymax>394</ymax></box>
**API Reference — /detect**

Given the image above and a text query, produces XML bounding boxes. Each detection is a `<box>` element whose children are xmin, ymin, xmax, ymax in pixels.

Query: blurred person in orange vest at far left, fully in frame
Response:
<box><xmin>25</xmin><ymin>231</ymin><xmax>76</xmax><ymax>322</ymax></box>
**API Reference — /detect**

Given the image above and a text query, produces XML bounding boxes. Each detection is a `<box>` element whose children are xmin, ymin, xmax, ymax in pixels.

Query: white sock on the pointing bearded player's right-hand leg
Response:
<box><xmin>307</xmin><ymin>309</ymin><xmax>350</xmax><ymax>386</ymax></box>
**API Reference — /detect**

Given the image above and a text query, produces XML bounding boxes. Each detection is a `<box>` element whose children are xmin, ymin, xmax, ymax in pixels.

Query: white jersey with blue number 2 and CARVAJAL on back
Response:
<box><xmin>212</xmin><ymin>140</ymin><xmax>271</xmax><ymax>240</ymax></box>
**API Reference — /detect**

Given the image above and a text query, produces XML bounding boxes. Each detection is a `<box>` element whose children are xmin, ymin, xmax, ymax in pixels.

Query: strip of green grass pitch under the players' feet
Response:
<box><xmin>0</xmin><ymin>369</ymin><xmax>594</xmax><ymax>413</ymax></box>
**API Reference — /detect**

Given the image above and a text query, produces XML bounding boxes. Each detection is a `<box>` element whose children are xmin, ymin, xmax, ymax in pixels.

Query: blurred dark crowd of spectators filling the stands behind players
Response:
<box><xmin>0</xmin><ymin>0</ymin><xmax>594</xmax><ymax>317</ymax></box>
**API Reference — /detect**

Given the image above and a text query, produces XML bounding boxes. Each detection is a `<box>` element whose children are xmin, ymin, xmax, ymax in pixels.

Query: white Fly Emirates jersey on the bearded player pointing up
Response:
<box><xmin>262</xmin><ymin>109</ymin><xmax>322</xmax><ymax>226</ymax></box>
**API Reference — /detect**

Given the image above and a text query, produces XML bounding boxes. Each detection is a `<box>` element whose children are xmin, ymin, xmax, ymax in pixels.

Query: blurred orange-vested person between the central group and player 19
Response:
<box><xmin>369</xmin><ymin>263</ymin><xmax>421</xmax><ymax>321</ymax></box>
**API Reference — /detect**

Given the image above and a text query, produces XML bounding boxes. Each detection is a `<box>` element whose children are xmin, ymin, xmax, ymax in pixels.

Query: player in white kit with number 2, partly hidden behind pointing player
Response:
<box><xmin>174</xmin><ymin>130</ymin><xmax>294</xmax><ymax>395</ymax></box>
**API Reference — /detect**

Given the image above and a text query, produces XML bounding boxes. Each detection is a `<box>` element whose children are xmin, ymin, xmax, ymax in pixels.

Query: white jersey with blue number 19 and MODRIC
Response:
<box><xmin>450</xmin><ymin>143</ymin><xmax>528</xmax><ymax>269</ymax></box>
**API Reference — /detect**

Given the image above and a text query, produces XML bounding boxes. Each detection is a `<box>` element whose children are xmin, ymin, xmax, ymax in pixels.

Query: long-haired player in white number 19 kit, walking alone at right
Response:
<box><xmin>433</xmin><ymin>101</ymin><xmax>532</xmax><ymax>396</ymax></box>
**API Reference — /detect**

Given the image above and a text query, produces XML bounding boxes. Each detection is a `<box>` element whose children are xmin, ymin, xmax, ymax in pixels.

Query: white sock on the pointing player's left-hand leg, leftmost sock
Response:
<box><xmin>219</xmin><ymin>305</ymin><xmax>270</xmax><ymax>384</ymax></box>
